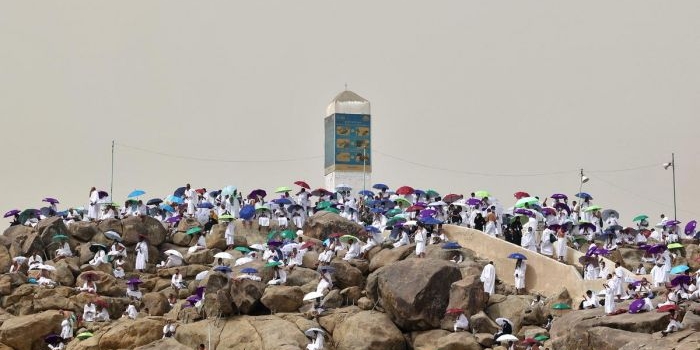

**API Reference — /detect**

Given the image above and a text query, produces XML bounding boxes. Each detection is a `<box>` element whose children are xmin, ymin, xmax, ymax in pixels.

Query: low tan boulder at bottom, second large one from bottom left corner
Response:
<box><xmin>100</xmin><ymin>317</ymin><xmax>164</xmax><ymax>349</ymax></box>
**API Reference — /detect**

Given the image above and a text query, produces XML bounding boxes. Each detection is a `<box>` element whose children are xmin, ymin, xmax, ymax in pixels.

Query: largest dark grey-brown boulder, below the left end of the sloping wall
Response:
<box><xmin>372</xmin><ymin>259</ymin><xmax>462</xmax><ymax>331</ymax></box>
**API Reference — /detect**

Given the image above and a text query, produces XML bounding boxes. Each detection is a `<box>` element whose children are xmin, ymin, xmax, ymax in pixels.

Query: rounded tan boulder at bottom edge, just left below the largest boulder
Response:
<box><xmin>333</xmin><ymin>311</ymin><xmax>407</xmax><ymax>350</ymax></box>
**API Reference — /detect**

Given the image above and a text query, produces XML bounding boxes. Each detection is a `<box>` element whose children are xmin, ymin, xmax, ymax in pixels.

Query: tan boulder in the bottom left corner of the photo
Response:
<box><xmin>0</xmin><ymin>311</ymin><xmax>63</xmax><ymax>350</ymax></box>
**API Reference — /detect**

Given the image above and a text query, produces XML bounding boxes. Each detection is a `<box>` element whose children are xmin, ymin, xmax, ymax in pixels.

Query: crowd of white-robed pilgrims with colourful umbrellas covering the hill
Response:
<box><xmin>5</xmin><ymin>181</ymin><xmax>700</xmax><ymax>350</ymax></box>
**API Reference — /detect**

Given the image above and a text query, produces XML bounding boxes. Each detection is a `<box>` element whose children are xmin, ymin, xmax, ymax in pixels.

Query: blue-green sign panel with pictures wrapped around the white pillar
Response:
<box><xmin>325</xmin><ymin>113</ymin><xmax>372</xmax><ymax>174</ymax></box>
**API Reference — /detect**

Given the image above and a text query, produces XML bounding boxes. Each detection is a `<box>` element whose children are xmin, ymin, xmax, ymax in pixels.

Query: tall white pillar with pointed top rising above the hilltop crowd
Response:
<box><xmin>324</xmin><ymin>90</ymin><xmax>372</xmax><ymax>192</ymax></box>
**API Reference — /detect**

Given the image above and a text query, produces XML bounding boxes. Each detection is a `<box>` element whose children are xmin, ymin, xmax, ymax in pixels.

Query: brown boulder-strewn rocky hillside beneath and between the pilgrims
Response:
<box><xmin>0</xmin><ymin>213</ymin><xmax>700</xmax><ymax>350</ymax></box>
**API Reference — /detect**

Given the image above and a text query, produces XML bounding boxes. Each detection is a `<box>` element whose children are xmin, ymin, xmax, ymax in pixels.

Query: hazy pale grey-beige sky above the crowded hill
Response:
<box><xmin>0</xmin><ymin>0</ymin><xmax>700</xmax><ymax>224</ymax></box>
